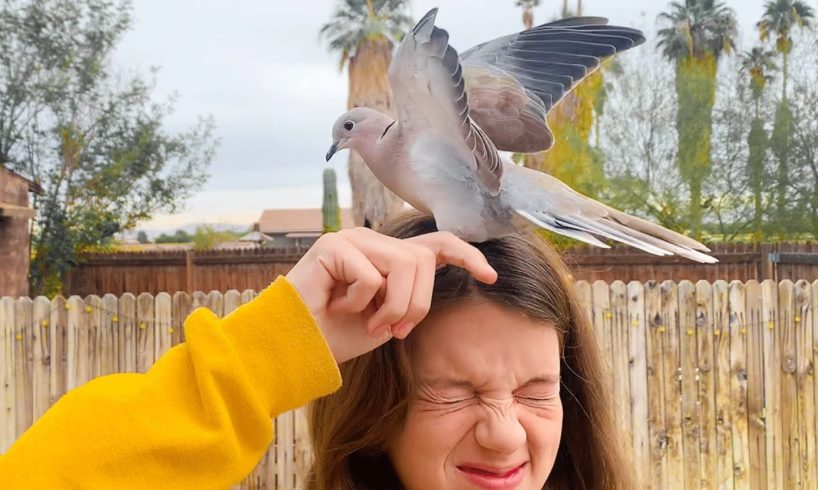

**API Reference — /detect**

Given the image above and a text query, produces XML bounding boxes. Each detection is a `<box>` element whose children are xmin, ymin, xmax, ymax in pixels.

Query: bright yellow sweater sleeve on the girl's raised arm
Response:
<box><xmin>0</xmin><ymin>277</ymin><xmax>341</xmax><ymax>490</ymax></box>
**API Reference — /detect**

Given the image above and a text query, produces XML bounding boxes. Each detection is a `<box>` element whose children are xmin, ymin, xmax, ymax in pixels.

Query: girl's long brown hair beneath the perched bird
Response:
<box><xmin>306</xmin><ymin>213</ymin><xmax>635</xmax><ymax>490</ymax></box>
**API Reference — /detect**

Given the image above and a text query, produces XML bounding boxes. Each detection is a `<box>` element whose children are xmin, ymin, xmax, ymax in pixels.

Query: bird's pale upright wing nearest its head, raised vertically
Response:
<box><xmin>389</xmin><ymin>9</ymin><xmax>503</xmax><ymax>194</ymax></box>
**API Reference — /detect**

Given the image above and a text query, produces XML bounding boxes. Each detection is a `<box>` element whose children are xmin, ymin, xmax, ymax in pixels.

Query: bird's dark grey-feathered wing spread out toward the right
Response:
<box><xmin>460</xmin><ymin>17</ymin><xmax>645</xmax><ymax>153</ymax></box>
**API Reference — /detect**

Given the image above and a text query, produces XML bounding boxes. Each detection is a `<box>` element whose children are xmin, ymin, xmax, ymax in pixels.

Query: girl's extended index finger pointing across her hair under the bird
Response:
<box><xmin>407</xmin><ymin>232</ymin><xmax>497</xmax><ymax>284</ymax></box>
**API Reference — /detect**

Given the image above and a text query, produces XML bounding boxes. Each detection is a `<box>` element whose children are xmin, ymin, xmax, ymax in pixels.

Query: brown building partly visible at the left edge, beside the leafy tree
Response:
<box><xmin>0</xmin><ymin>166</ymin><xmax>43</xmax><ymax>297</ymax></box>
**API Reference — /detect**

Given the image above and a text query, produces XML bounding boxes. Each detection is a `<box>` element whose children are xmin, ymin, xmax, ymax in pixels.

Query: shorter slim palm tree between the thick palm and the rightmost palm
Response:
<box><xmin>741</xmin><ymin>47</ymin><xmax>778</xmax><ymax>243</ymax></box>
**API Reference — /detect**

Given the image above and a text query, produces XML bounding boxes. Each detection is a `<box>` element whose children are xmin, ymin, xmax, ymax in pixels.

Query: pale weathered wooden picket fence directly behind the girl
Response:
<box><xmin>0</xmin><ymin>280</ymin><xmax>818</xmax><ymax>490</ymax></box>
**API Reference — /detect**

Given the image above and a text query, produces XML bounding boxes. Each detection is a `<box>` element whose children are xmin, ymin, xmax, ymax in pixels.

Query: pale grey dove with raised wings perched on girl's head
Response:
<box><xmin>326</xmin><ymin>8</ymin><xmax>717</xmax><ymax>263</ymax></box>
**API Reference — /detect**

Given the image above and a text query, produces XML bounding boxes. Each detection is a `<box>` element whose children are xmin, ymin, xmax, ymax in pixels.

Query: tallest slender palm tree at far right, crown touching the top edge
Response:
<box><xmin>756</xmin><ymin>0</ymin><xmax>815</xmax><ymax>233</ymax></box>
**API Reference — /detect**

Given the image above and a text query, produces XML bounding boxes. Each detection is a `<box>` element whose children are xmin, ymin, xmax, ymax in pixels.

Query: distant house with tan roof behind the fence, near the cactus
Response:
<box><xmin>253</xmin><ymin>208</ymin><xmax>353</xmax><ymax>247</ymax></box>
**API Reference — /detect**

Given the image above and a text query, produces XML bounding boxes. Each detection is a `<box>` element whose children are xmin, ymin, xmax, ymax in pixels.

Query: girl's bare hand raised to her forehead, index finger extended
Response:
<box><xmin>287</xmin><ymin>228</ymin><xmax>497</xmax><ymax>363</ymax></box>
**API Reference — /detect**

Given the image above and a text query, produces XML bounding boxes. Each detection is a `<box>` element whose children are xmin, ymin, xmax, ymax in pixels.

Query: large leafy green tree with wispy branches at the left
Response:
<box><xmin>0</xmin><ymin>0</ymin><xmax>216</xmax><ymax>294</ymax></box>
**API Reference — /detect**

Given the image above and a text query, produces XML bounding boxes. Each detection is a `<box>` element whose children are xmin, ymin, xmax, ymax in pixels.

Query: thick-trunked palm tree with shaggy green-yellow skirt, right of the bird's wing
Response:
<box><xmin>659</xmin><ymin>0</ymin><xmax>737</xmax><ymax>238</ymax></box>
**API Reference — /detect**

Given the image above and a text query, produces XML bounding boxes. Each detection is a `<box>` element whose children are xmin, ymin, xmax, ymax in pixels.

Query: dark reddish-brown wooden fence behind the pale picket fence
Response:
<box><xmin>63</xmin><ymin>242</ymin><xmax>818</xmax><ymax>296</ymax></box>
